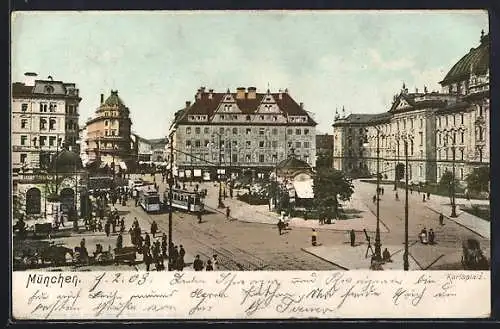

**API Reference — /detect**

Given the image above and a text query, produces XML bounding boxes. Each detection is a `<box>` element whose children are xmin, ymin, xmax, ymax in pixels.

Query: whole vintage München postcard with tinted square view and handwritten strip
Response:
<box><xmin>10</xmin><ymin>10</ymin><xmax>491</xmax><ymax>320</ymax></box>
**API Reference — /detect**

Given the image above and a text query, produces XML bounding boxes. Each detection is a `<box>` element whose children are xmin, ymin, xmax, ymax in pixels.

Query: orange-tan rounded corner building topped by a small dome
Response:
<box><xmin>83</xmin><ymin>90</ymin><xmax>137</xmax><ymax>172</ymax></box>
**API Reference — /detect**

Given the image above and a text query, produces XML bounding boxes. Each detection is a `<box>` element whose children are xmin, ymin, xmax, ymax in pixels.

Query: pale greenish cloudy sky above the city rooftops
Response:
<box><xmin>11</xmin><ymin>10</ymin><xmax>488</xmax><ymax>138</ymax></box>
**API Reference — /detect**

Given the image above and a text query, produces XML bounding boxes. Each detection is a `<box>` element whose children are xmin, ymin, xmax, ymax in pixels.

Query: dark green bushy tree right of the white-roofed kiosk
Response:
<box><xmin>313</xmin><ymin>168</ymin><xmax>354</xmax><ymax>219</ymax></box>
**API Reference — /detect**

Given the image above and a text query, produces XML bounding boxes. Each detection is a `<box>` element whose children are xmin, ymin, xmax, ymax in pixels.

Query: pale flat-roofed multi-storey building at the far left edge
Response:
<box><xmin>11</xmin><ymin>73</ymin><xmax>81</xmax><ymax>172</ymax></box>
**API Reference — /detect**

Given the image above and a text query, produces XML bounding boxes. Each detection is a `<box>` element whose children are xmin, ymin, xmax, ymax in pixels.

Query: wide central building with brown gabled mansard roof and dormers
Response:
<box><xmin>167</xmin><ymin>87</ymin><xmax>316</xmax><ymax>179</ymax></box>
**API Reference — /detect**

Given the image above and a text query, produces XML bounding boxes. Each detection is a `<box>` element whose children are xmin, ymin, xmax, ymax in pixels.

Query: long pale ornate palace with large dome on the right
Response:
<box><xmin>333</xmin><ymin>33</ymin><xmax>490</xmax><ymax>183</ymax></box>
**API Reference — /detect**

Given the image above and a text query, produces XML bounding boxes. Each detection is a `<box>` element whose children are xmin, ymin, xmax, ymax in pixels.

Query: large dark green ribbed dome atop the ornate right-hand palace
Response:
<box><xmin>441</xmin><ymin>35</ymin><xmax>490</xmax><ymax>85</ymax></box>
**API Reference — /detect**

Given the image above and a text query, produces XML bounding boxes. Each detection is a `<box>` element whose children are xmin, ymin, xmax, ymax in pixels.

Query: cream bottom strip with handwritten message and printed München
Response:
<box><xmin>12</xmin><ymin>271</ymin><xmax>490</xmax><ymax>319</ymax></box>
